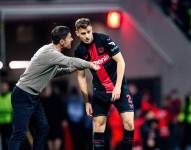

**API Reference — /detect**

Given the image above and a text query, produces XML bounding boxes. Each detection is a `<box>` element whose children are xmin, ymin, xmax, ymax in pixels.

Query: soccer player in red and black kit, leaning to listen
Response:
<box><xmin>75</xmin><ymin>18</ymin><xmax>134</xmax><ymax>150</ymax></box>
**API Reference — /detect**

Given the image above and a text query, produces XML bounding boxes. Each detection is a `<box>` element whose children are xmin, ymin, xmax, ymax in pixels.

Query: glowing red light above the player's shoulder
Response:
<box><xmin>107</xmin><ymin>11</ymin><xmax>121</xmax><ymax>29</ymax></box>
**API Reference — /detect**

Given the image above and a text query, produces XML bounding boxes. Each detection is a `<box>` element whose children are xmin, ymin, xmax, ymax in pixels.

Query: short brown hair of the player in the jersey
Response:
<box><xmin>75</xmin><ymin>18</ymin><xmax>91</xmax><ymax>30</ymax></box>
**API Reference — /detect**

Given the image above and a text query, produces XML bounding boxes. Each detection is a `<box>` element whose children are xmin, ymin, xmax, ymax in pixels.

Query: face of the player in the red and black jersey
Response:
<box><xmin>76</xmin><ymin>26</ymin><xmax>93</xmax><ymax>44</ymax></box>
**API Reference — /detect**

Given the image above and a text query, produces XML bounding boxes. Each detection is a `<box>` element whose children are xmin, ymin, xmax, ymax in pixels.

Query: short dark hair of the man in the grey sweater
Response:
<box><xmin>51</xmin><ymin>26</ymin><xmax>70</xmax><ymax>44</ymax></box>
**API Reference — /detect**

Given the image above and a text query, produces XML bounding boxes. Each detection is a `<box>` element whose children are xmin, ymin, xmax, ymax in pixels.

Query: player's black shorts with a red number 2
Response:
<box><xmin>92</xmin><ymin>86</ymin><xmax>134</xmax><ymax>117</ymax></box>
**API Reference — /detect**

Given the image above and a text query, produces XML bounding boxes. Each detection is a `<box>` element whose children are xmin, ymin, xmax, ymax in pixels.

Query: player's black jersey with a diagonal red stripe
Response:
<box><xmin>75</xmin><ymin>33</ymin><xmax>126</xmax><ymax>93</ymax></box>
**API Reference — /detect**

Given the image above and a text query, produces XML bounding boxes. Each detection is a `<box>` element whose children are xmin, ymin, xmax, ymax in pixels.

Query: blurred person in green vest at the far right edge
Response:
<box><xmin>178</xmin><ymin>88</ymin><xmax>191</xmax><ymax>149</ymax></box>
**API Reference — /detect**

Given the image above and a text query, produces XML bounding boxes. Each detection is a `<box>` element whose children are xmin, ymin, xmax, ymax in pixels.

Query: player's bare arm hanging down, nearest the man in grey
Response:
<box><xmin>77</xmin><ymin>70</ymin><xmax>93</xmax><ymax>117</ymax></box>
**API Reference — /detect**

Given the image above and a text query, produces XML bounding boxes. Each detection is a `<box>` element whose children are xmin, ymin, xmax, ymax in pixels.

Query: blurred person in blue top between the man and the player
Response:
<box><xmin>66</xmin><ymin>87</ymin><xmax>88</xmax><ymax>150</ymax></box>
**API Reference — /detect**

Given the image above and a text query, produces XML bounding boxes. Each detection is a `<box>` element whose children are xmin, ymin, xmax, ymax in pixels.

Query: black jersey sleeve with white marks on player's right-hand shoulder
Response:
<box><xmin>103</xmin><ymin>35</ymin><xmax>120</xmax><ymax>57</ymax></box>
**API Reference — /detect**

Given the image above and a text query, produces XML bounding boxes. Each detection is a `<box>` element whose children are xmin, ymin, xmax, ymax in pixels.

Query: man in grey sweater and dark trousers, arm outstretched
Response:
<box><xmin>9</xmin><ymin>26</ymin><xmax>99</xmax><ymax>150</ymax></box>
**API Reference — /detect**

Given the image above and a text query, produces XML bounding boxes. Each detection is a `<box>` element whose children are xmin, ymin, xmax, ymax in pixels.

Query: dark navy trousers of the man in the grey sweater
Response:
<box><xmin>9</xmin><ymin>87</ymin><xmax>49</xmax><ymax>150</ymax></box>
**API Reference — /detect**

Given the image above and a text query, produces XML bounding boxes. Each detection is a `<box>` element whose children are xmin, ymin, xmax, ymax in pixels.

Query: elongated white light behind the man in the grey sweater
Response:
<box><xmin>9</xmin><ymin>61</ymin><xmax>30</xmax><ymax>69</ymax></box>
